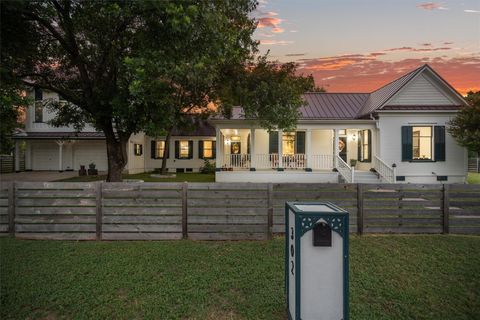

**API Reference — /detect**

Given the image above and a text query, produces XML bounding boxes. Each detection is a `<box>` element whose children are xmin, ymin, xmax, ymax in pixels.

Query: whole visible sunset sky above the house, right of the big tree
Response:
<box><xmin>255</xmin><ymin>0</ymin><xmax>480</xmax><ymax>94</ymax></box>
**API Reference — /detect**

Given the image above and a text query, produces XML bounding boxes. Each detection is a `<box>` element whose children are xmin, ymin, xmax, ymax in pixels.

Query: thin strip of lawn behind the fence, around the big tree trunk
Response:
<box><xmin>58</xmin><ymin>172</ymin><xmax>215</xmax><ymax>182</ymax></box>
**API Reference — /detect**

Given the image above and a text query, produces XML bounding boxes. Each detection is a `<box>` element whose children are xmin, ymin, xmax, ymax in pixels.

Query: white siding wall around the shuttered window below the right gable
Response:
<box><xmin>378</xmin><ymin>113</ymin><xmax>467</xmax><ymax>183</ymax></box>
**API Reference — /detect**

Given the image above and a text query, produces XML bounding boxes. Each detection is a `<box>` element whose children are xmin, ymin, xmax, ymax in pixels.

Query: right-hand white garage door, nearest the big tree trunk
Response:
<box><xmin>73</xmin><ymin>141</ymin><xmax>108</xmax><ymax>171</ymax></box>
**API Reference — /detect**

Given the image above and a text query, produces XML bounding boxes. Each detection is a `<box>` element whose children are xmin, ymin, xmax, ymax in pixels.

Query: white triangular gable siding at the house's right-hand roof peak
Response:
<box><xmin>387</xmin><ymin>73</ymin><xmax>458</xmax><ymax>106</ymax></box>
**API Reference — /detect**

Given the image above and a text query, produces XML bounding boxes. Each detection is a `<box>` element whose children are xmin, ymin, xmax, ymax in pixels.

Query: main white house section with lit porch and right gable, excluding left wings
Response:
<box><xmin>212</xmin><ymin>65</ymin><xmax>467</xmax><ymax>183</ymax></box>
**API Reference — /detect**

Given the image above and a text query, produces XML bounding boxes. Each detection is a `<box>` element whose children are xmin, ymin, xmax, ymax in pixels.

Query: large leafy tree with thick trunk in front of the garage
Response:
<box><xmin>1</xmin><ymin>0</ymin><xmax>316</xmax><ymax>181</ymax></box>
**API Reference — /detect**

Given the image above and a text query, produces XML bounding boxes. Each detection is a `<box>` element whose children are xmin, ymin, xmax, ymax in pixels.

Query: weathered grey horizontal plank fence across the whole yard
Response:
<box><xmin>0</xmin><ymin>182</ymin><xmax>480</xmax><ymax>240</ymax></box>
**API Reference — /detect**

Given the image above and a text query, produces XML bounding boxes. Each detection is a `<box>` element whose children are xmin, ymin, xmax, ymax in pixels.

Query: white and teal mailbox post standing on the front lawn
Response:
<box><xmin>285</xmin><ymin>202</ymin><xmax>348</xmax><ymax>320</ymax></box>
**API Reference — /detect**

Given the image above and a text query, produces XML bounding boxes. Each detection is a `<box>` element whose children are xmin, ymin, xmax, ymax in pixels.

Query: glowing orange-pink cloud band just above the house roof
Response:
<box><xmin>297</xmin><ymin>54</ymin><xmax>480</xmax><ymax>94</ymax></box>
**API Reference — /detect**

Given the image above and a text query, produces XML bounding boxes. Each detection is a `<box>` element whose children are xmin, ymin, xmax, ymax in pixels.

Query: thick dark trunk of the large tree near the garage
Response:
<box><xmin>104</xmin><ymin>128</ymin><xmax>129</xmax><ymax>182</ymax></box>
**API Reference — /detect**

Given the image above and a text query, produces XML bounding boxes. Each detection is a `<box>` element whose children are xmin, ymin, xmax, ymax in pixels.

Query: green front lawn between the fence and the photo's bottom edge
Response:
<box><xmin>0</xmin><ymin>235</ymin><xmax>480</xmax><ymax>319</ymax></box>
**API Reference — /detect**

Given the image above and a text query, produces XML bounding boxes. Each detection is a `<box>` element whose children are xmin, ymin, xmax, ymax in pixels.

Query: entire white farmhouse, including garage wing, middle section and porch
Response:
<box><xmin>14</xmin><ymin>65</ymin><xmax>467</xmax><ymax>183</ymax></box>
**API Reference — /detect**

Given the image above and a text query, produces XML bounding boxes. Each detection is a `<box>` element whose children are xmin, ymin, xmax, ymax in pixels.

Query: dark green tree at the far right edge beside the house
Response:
<box><xmin>448</xmin><ymin>91</ymin><xmax>480</xmax><ymax>155</ymax></box>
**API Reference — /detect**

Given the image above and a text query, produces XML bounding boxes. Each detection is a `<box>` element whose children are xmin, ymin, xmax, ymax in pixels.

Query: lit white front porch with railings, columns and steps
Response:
<box><xmin>216</xmin><ymin>125</ymin><xmax>393</xmax><ymax>182</ymax></box>
